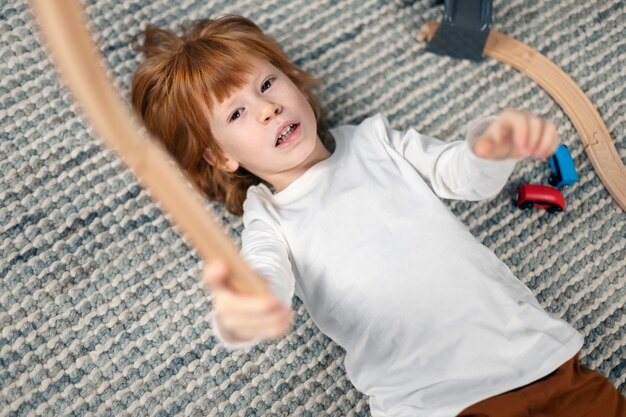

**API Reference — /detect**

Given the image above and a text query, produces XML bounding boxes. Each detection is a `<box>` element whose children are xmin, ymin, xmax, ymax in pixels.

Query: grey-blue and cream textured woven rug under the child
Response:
<box><xmin>0</xmin><ymin>0</ymin><xmax>626</xmax><ymax>416</ymax></box>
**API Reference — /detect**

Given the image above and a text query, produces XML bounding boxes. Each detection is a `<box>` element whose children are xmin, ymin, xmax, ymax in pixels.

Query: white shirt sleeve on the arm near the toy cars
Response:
<box><xmin>383</xmin><ymin>113</ymin><xmax>517</xmax><ymax>201</ymax></box>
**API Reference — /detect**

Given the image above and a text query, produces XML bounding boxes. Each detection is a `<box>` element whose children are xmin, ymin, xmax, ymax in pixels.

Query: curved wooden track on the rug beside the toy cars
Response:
<box><xmin>417</xmin><ymin>21</ymin><xmax>626</xmax><ymax>211</ymax></box>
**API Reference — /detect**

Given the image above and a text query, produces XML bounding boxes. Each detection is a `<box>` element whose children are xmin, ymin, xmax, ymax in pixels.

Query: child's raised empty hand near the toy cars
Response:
<box><xmin>472</xmin><ymin>110</ymin><xmax>560</xmax><ymax>160</ymax></box>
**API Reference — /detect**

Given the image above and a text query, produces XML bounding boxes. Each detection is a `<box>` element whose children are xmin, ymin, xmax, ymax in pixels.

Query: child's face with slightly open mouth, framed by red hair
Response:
<box><xmin>207</xmin><ymin>59</ymin><xmax>329</xmax><ymax>191</ymax></box>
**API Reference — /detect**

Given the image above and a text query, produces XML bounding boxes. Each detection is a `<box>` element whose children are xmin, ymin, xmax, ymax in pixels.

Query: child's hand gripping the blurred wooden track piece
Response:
<box><xmin>203</xmin><ymin>261</ymin><xmax>294</xmax><ymax>343</ymax></box>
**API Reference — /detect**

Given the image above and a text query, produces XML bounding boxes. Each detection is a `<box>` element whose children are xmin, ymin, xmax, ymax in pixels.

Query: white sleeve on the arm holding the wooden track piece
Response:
<box><xmin>211</xmin><ymin>193</ymin><xmax>295</xmax><ymax>350</ymax></box>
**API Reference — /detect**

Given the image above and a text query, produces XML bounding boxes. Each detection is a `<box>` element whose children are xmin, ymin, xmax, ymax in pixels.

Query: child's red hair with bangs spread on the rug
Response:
<box><xmin>132</xmin><ymin>16</ymin><xmax>326</xmax><ymax>215</ymax></box>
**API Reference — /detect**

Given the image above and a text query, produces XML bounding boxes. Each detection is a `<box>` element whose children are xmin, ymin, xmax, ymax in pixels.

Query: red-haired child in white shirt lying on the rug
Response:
<box><xmin>132</xmin><ymin>16</ymin><xmax>626</xmax><ymax>417</ymax></box>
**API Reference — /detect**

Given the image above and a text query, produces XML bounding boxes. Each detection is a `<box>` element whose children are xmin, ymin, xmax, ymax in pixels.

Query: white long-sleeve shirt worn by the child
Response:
<box><xmin>216</xmin><ymin>115</ymin><xmax>582</xmax><ymax>417</ymax></box>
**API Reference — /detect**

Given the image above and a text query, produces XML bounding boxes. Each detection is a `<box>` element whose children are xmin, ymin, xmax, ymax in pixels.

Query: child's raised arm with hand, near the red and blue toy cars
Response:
<box><xmin>386</xmin><ymin>110</ymin><xmax>558</xmax><ymax>200</ymax></box>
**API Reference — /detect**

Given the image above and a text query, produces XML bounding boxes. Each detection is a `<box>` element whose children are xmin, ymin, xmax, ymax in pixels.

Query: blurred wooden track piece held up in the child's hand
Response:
<box><xmin>31</xmin><ymin>0</ymin><xmax>269</xmax><ymax>293</ymax></box>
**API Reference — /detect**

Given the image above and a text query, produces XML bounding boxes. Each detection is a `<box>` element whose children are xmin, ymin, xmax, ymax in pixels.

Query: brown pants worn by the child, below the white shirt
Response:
<box><xmin>459</xmin><ymin>354</ymin><xmax>626</xmax><ymax>417</ymax></box>
